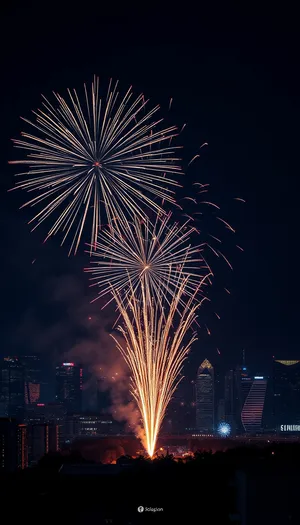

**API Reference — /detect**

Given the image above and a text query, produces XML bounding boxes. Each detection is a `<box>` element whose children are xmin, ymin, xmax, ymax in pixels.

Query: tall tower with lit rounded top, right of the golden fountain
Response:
<box><xmin>196</xmin><ymin>359</ymin><xmax>215</xmax><ymax>434</ymax></box>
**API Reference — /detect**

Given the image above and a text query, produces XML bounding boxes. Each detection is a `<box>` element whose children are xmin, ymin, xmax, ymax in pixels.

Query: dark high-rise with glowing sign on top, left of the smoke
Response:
<box><xmin>55</xmin><ymin>363</ymin><xmax>82</xmax><ymax>413</ymax></box>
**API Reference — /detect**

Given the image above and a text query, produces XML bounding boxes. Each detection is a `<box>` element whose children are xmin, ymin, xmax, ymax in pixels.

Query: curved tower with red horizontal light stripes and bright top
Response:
<box><xmin>241</xmin><ymin>376</ymin><xmax>267</xmax><ymax>434</ymax></box>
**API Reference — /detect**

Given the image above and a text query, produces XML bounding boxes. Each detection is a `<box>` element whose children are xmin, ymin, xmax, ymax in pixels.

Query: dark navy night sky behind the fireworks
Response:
<box><xmin>0</xmin><ymin>7</ymin><xmax>300</xmax><ymax>376</ymax></box>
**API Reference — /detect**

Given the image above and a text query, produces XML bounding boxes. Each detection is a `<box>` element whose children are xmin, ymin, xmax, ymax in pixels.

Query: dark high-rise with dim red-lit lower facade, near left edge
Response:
<box><xmin>20</xmin><ymin>355</ymin><xmax>42</xmax><ymax>404</ymax></box>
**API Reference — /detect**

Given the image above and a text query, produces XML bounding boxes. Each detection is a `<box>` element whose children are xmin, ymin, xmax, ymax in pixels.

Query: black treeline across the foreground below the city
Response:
<box><xmin>2</xmin><ymin>444</ymin><xmax>300</xmax><ymax>525</ymax></box>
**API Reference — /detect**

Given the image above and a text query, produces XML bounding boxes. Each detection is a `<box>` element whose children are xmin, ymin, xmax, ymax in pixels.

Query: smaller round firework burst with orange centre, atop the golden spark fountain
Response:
<box><xmin>86</xmin><ymin>214</ymin><xmax>211</xmax><ymax>307</ymax></box>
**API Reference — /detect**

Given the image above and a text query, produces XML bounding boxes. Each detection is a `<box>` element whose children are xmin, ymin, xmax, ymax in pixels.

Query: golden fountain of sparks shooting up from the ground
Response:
<box><xmin>112</xmin><ymin>272</ymin><xmax>204</xmax><ymax>457</ymax></box>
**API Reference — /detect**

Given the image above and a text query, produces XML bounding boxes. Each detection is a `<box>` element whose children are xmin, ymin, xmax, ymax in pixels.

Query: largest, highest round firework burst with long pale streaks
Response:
<box><xmin>11</xmin><ymin>77</ymin><xmax>181</xmax><ymax>253</ymax></box>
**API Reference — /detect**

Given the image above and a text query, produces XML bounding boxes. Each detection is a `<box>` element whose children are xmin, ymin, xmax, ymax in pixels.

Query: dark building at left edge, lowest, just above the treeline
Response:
<box><xmin>0</xmin><ymin>418</ymin><xmax>28</xmax><ymax>473</ymax></box>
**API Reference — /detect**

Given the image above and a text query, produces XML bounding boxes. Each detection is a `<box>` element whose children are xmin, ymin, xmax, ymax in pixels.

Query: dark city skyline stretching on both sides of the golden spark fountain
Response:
<box><xmin>0</xmin><ymin>352</ymin><xmax>300</xmax><ymax>435</ymax></box>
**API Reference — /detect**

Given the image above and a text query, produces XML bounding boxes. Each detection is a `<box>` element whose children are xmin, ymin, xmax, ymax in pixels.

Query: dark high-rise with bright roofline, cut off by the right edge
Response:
<box><xmin>273</xmin><ymin>359</ymin><xmax>300</xmax><ymax>429</ymax></box>
